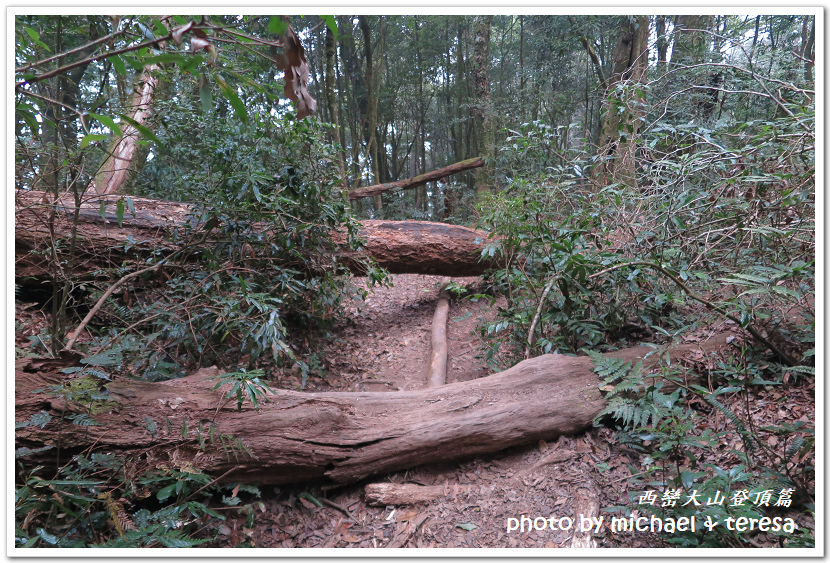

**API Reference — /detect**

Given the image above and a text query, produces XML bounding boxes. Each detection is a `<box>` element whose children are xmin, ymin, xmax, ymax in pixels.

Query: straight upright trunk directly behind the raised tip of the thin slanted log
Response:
<box><xmin>473</xmin><ymin>16</ymin><xmax>495</xmax><ymax>195</ymax></box>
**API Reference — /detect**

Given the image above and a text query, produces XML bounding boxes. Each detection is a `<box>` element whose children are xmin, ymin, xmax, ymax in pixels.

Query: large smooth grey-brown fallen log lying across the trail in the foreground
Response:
<box><xmin>15</xmin><ymin>338</ymin><xmax>724</xmax><ymax>486</ymax></box>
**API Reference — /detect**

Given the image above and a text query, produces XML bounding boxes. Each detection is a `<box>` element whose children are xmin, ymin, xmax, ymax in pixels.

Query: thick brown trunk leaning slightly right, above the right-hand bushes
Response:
<box><xmin>594</xmin><ymin>16</ymin><xmax>649</xmax><ymax>187</ymax></box>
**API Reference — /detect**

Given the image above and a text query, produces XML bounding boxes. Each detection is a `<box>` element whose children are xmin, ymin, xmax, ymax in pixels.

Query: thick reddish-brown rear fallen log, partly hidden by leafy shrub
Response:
<box><xmin>15</xmin><ymin>192</ymin><xmax>500</xmax><ymax>283</ymax></box>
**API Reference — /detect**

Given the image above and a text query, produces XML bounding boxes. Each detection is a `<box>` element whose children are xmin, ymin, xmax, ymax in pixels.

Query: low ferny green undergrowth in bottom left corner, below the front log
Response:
<box><xmin>14</xmin><ymin>451</ymin><xmax>259</xmax><ymax>547</ymax></box>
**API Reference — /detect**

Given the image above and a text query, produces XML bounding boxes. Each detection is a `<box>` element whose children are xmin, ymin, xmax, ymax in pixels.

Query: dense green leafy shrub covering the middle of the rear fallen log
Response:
<box><xmin>88</xmin><ymin>111</ymin><xmax>377</xmax><ymax>379</ymax></box>
